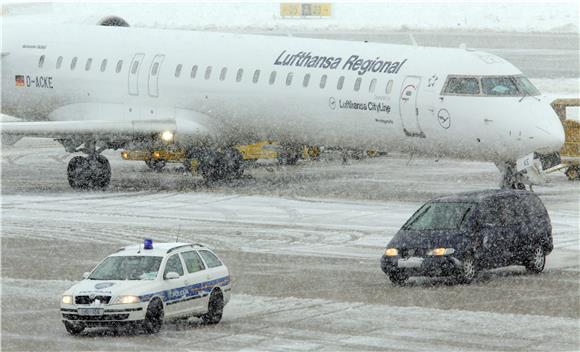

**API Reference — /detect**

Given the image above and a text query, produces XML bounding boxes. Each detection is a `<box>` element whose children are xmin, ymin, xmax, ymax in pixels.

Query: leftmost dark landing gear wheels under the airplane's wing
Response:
<box><xmin>67</xmin><ymin>154</ymin><xmax>111</xmax><ymax>190</ymax></box>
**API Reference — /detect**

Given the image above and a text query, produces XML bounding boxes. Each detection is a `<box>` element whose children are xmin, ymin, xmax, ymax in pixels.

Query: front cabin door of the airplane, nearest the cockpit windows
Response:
<box><xmin>399</xmin><ymin>76</ymin><xmax>425</xmax><ymax>138</ymax></box>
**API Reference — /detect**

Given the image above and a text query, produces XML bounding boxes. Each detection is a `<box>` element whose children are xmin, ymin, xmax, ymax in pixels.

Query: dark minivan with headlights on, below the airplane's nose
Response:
<box><xmin>381</xmin><ymin>190</ymin><xmax>554</xmax><ymax>284</ymax></box>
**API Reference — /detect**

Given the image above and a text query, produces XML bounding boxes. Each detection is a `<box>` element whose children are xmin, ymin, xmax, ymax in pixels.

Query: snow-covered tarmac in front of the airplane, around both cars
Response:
<box><xmin>1</xmin><ymin>139</ymin><xmax>580</xmax><ymax>351</ymax></box>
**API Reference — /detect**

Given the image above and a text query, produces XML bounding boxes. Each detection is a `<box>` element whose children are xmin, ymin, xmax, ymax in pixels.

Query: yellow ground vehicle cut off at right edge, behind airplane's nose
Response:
<box><xmin>551</xmin><ymin>98</ymin><xmax>580</xmax><ymax>180</ymax></box>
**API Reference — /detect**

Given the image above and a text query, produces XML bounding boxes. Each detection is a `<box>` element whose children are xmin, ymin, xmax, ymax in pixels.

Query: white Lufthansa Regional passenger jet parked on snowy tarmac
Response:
<box><xmin>0</xmin><ymin>16</ymin><xmax>564</xmax><ymax>190</ymax></box>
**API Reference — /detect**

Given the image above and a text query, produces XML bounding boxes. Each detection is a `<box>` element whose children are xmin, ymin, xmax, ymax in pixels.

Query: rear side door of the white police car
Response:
<box><xmin>181</xmin><ymin>251</ymin><xmax>208</xmax><ymax>313</ymax></box>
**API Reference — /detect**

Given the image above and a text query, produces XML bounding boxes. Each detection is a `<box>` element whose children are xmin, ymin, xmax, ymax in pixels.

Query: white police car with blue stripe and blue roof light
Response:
<box><xmin>60</xmin><ymin>240</ymin><xmax>231</xmax><ymax>335</ymax></box>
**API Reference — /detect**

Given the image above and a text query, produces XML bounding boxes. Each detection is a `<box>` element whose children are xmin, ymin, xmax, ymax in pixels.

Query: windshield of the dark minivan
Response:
<box><xmin>403</xmin><ymin>202</ymin><xmax>475</xmax><ymax>231</ymax></box>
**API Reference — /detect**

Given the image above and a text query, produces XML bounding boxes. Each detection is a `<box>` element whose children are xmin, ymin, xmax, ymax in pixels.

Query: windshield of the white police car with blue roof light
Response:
<box><xmin>89</xmin><ymin>256</ymin><xmax>163</xmax><ymax>280</ymax></box>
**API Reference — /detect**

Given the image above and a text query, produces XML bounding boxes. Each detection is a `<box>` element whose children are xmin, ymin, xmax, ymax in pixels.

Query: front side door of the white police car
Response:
<box><xmin>163</xmin><ymin>253</ymin><xmax>188</xmax><ymax>316</ymax></box>
